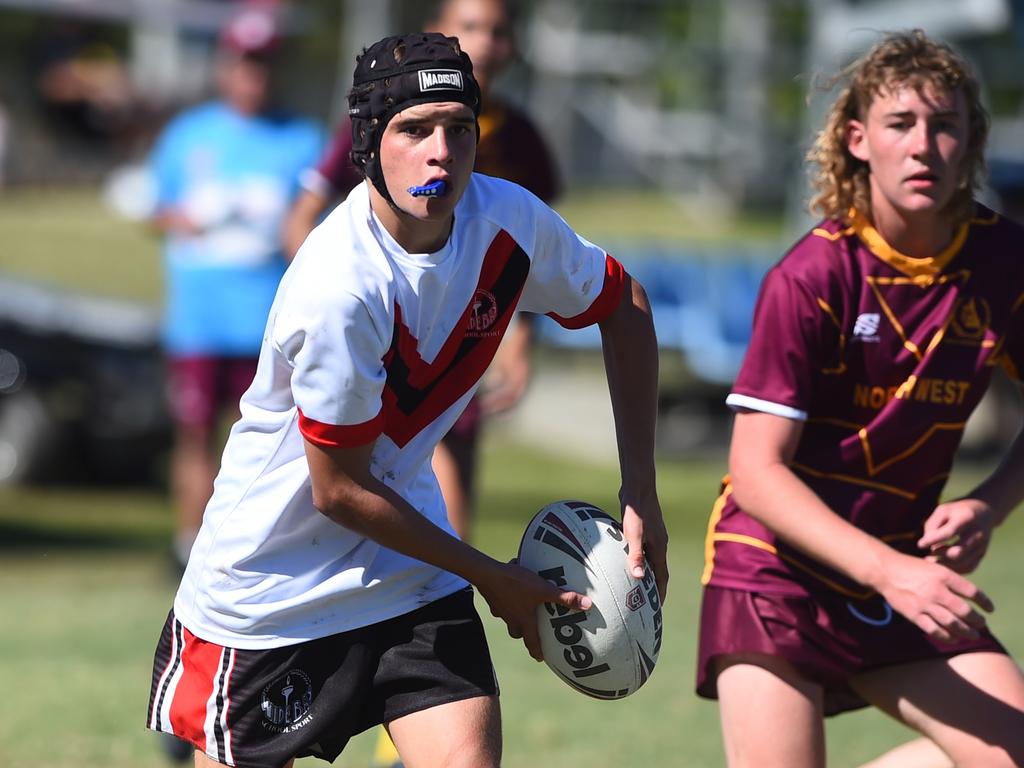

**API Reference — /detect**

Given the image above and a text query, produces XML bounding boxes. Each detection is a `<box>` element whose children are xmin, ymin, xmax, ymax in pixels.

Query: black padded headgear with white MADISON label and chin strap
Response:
<box><xmin>348</xmin><ymin>32</ymin><xmax>480</xmax><ymax>207</ymax></box>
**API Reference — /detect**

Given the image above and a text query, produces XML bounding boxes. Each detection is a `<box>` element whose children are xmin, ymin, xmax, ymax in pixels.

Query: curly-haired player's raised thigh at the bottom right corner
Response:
<box><xmin>851</xmin><ymin>652</ymin><xmax>1024</xmax><ymax>768</ymax></box>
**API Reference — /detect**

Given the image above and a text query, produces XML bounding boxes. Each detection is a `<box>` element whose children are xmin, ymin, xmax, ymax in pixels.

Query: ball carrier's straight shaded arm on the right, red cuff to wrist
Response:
<box><xmin>601</xmin><ymin>279</ymin><xmax>658</xmax><ymax>496</ymax></box>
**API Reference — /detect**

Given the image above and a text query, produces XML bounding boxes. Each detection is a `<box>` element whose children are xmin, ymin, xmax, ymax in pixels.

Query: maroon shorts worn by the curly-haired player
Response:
<box><xmin>696</xmin><ymin>587</ymin><xmax>1007</xmax><ymax>715</ymax></box>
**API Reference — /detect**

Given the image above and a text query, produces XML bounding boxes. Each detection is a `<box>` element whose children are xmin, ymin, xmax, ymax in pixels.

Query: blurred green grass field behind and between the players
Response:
<box><xmin>0</xmin><ymin>190</ymin><xmax>1024</xmax><ymax>768</ymax></box>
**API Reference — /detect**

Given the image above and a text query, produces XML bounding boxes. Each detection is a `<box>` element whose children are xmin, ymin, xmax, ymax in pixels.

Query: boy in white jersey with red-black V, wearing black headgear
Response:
<box><xmin>148</xmin><ymin>34</ymin><xmax>668</xmax><ymax>768</ymax></box>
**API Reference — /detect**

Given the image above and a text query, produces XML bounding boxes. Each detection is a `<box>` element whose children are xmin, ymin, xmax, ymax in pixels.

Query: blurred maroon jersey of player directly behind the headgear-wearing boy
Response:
<box><xmin>302</xmin><ymin>98</ymin><xmax>559</xmax><ymax>203</ymax></box>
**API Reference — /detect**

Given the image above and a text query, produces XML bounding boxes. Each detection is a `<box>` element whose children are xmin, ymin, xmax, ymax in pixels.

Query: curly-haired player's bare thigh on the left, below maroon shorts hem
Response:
<box><xmin>716</xmin><ymin>653</ymin><xmax>825</xmax><ymax>768</ymax></box>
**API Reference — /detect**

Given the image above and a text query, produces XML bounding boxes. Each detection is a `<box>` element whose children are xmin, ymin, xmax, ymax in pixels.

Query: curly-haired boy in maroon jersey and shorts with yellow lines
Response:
<box><xmin>697</xmin><ymin>31</ymin><xmax>1024</xmax><ymax>768</ymax></box>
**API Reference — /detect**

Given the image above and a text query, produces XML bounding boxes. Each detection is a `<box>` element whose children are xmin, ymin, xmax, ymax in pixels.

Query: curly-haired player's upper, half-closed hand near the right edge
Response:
<box><xmin>918</xmin><ymin>499</ymin><xmax>995</xmax><ymax>573</ymax></box>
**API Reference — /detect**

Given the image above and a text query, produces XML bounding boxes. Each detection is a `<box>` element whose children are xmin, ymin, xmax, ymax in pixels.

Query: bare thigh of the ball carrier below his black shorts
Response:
<box><xmin>388</xmin><ymin>696</ymin><xmax>502</xmax><ymax>768</ymax></box>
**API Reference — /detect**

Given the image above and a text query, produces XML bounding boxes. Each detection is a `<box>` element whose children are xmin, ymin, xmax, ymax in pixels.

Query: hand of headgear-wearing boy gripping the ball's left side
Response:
<box><xmin>475</xmin><ymin>562</ymin><xmax>593</xmax><ymax>662</ymax></box>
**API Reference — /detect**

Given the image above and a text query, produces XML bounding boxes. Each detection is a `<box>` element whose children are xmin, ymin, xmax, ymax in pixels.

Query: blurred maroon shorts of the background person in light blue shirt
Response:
<box><xmin>167</xmin><ymin>356</ymin><xmax>257</xmax><ymax>430</ymax></box>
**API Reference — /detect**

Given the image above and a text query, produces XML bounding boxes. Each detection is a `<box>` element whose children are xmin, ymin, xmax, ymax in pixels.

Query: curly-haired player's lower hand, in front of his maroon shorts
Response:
<box><xmin>879</xmin><ymin>552</ymin><xmax>995</xmax><ymax>643</ymax></box>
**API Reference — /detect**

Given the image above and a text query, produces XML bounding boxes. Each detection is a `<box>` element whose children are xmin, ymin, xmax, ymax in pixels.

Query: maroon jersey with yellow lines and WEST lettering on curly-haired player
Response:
<box><xmin>702</xmin><ymin>206</ymin><xmax>1024</xmax><ymax>597</ymax></box>
